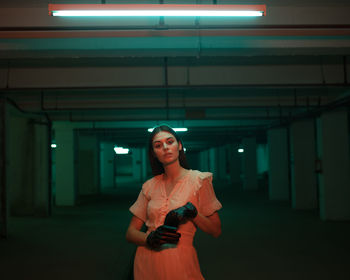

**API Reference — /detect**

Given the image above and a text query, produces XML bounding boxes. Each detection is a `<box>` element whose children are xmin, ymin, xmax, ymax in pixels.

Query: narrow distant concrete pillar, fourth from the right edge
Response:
<box><xmin>242</xmin><ymin>137</ymin><xmax>258</xmax><ymax>190</ymax></box>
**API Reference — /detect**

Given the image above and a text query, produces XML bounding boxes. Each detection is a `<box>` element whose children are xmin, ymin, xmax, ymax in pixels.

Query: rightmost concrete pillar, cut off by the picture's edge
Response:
<box><xmin>317</xmin><ymin>109</ymin><xmax>350</xmax><ymax>220</ymax></box>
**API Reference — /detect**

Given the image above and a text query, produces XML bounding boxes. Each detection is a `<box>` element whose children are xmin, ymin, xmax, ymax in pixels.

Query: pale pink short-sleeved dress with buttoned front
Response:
<box><xmin>130</xmin><ymin>170</ymin><xmax>222</xmax><ymax>280</ymax></box>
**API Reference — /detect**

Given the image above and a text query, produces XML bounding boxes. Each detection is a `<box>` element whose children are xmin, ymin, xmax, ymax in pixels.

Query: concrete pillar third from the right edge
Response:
<box><xmin>267</xmin><ymin>128</ymin><xmax>289</xmax><ymax>200</ymax></box>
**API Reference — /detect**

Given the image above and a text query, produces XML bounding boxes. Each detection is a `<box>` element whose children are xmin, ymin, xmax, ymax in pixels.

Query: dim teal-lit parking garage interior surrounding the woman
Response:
<box><xmin>0</xmin><ymin>0</ymin><xmax>350</xmax><ymax>280</ymax></box>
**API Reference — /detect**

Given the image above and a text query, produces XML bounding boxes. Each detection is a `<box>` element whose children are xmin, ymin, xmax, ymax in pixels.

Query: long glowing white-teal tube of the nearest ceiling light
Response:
<box><xmin>52</xmin><ymin>10</ymin><xmax>264</xmax><ymax>17</ymax></box>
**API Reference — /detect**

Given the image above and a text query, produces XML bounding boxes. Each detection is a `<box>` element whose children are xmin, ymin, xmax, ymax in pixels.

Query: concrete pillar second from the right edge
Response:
<box><xmin>290</xmin><ymin>120</ymin><xmax>318</xmax><ymax>209</ymax></box>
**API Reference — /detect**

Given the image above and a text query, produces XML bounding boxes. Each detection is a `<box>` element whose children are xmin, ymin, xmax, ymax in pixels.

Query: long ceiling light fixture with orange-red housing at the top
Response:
<box><xmin>49</xmin><ymin>4</ymin><xmax>266</xmax><ymax>17</ymax></box>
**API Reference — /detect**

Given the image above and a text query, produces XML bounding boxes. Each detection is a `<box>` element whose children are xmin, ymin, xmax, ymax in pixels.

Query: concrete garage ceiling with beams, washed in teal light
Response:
<box><xmin>0</xmin><ymin>0</ymin><xmax>350</xmax><ymax>148</ymax></box>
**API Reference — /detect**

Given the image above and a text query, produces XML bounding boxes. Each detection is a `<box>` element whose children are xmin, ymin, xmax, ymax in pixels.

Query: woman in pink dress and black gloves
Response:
<box><xmin>126</xmin><ymin>125</ymin><xmax>222</xmax><ymax>280</ymax></box>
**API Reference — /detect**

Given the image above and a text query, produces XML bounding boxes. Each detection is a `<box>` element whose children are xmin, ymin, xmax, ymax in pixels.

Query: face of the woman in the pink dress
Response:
<box><xmin>152</xmin><ymin>131</ymin><xmax>182</xmax><ymax>166</ymax></box>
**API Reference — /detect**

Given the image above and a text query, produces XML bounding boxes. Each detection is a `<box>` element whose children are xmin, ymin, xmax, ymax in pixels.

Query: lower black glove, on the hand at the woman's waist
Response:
<box><xmin>146</xmin><ymin>226</ymin><xmax>181</xmax><ymax>250</ymax></box>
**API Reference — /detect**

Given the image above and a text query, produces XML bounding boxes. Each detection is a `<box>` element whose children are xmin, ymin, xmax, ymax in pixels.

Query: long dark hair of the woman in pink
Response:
<box><xmin>148</xmin><ymin>124</ymin><xmax>189</xmax><ymax>176</ymax></box>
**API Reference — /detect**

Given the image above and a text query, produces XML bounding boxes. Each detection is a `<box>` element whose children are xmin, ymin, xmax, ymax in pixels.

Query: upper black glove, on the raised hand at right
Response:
<box><xmin>164</xmin><ymin>202</ymin><xmax>198</xmax><ymax>228</ymax></box>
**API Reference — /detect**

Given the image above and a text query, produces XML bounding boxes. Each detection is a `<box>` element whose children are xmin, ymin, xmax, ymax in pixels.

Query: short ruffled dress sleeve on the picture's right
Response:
<box><xmin>198</xmin><ymin>173</ymin><xmax>222</xmax><ymax>217</ymax></box>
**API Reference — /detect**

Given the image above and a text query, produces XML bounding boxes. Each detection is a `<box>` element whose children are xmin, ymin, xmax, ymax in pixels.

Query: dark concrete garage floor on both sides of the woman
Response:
<box><xmin>0</xmin><ymin>183</ymin><xmax>350</xmax><ymax>280</ymax></box>
